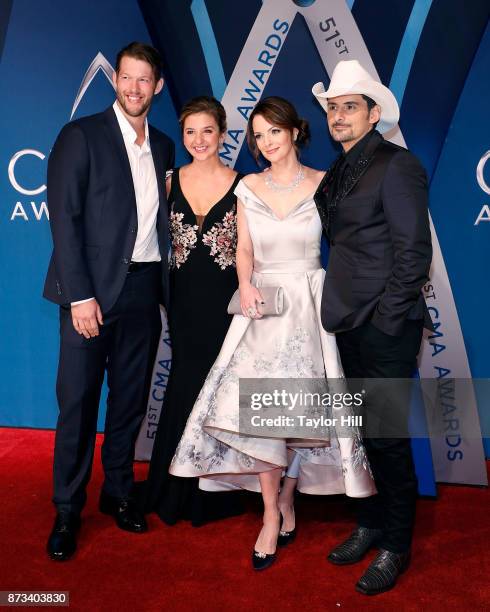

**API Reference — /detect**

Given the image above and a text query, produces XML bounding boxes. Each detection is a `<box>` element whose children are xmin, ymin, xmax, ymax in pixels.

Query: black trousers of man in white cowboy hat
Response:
<box><xmin>336</xmin><ymin>320</ymin><xmax>423</xmax><ymax>553</ymax></box>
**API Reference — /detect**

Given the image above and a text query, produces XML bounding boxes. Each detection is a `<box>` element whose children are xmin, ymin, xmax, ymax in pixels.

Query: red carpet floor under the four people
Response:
<box><xmin>0</xmin><ymin>429</ymin><xmax>490</xmax><ymax>612</ymax></box>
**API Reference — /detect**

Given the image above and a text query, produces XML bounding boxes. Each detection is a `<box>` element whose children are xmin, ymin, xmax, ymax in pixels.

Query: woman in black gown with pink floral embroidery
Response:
<box><xmin>141</xmin><ymin>96</ymin><xmax>242</xmax><ymax>526</ymax></box>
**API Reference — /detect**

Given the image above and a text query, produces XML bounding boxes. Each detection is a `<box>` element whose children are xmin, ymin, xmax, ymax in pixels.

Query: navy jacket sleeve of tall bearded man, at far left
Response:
<box><xmin>48</xmin><ymin>123</ymin><xmax>95</xmax><ymax>302</ymax></box>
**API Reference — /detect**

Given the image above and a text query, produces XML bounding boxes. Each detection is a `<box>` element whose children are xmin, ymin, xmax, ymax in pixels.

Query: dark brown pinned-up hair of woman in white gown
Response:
<box><xmin>247</xmin><ymin>96</ymin><xmax>310</xmax><ymax>161</ymax></box>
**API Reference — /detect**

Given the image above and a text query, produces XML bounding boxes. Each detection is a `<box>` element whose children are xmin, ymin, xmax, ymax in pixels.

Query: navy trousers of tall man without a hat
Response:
<box><xmin>53</xmin><ymin>263</ymin><xmax>161</xmax><ymax>513</ymax></box>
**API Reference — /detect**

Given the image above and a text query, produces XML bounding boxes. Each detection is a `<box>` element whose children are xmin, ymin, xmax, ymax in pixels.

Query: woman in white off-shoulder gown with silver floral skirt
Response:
<box><xmin>170</xmin><ymin>97</ymin><xmax>376</xmax><ymax>569</ymax></box>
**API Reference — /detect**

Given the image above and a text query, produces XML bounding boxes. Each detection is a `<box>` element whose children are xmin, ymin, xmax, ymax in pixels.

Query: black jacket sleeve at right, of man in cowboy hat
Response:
<box><xmin>371</xmin><ymin>150</ymin><xmax>432</xmax><ymax>336</ymax></box>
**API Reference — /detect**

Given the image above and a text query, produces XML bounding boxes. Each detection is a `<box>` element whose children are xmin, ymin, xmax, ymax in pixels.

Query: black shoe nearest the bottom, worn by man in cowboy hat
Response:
<box><xmin>356</xmin><ymin>550</ymin><xmax>410</xmax><ymax>595</ymax></box>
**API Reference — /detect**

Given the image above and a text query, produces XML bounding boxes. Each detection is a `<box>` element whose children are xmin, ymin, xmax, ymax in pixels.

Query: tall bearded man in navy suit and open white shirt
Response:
<box><xmin>44</xmin><ymin>42</ymin><xmax>174</xmax><ymax>560</ymax></box>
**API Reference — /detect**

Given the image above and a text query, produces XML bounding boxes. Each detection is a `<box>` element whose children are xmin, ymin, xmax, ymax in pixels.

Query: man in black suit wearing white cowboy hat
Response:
<box><xmin>313</xmin><ymin>60</ymin><xmax>432</xmax><ymax>595</ymax></box>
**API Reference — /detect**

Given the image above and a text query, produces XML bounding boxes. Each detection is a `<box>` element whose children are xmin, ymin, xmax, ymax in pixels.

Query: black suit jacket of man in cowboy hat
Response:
<box><xmin>315</xmin><ymin>132</ymin><xmax>432</xmax><ymax>336</ymax></box>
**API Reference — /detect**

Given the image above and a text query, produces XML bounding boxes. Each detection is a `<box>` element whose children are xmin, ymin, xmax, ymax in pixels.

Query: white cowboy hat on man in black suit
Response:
<box><xmin>311</xmin><ymin>60</ymin><xmax>400</xmax><ymax>133</ymax></box>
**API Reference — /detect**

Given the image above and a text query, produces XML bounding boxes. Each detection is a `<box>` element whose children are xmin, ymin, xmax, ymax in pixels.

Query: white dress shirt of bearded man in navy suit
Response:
<box><xmin>71</xmin><ymin>100</ymin><xmax>163</xmax><ymax>306</ymax></box>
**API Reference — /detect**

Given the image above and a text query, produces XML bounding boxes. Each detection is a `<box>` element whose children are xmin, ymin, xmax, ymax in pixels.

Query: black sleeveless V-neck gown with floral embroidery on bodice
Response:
<box><xmin>144</xmin><ymin>169</ymin><xmax>242</xmax><ymax>526</ymax></box>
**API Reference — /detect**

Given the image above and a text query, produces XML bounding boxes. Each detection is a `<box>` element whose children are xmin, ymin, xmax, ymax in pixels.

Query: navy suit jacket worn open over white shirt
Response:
<box><xmin>44</xmin><ymin>107</ymin><xmax>174</xmax><ymax>312</ymax></box>
